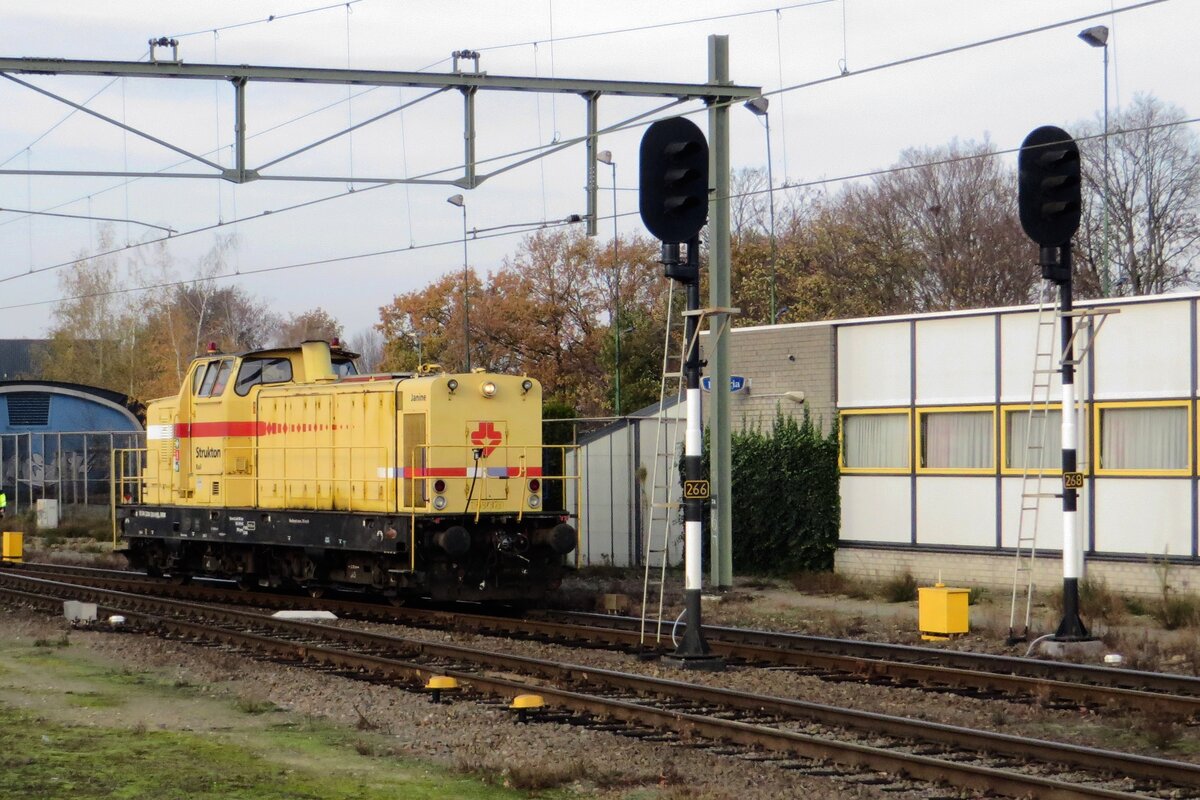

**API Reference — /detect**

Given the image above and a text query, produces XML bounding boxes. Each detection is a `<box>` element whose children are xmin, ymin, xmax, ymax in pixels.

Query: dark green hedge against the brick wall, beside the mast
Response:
<box><xmin>704</xmin><ymin>405</ymin><xmax>841</xmax><ymax>575</ymax></box>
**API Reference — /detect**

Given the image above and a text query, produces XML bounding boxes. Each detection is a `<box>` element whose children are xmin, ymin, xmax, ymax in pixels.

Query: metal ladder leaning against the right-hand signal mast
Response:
<box><xmin>1008</xmin><ymin>281</ymin><xmax>1062</xmax><ymax>642</ymax></box>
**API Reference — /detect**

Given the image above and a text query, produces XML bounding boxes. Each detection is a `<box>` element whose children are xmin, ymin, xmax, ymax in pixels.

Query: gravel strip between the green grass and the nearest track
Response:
<box><xmin>0</xmin><ymin>613</ymin><xmax>916</xmax><ymax>800</ymax></box>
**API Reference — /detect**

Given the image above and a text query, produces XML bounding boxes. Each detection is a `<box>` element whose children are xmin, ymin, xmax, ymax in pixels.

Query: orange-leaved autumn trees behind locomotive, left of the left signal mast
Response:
<box><xmin>378</xmin><ymin>225</ymin><xmax>664</xmax><ymax>414</ymax></box>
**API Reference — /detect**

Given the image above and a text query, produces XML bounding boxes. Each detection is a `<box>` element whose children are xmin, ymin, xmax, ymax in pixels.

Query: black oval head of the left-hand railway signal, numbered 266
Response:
<box><xmin>638</xmin><ymin>116</ymin><xmax>708</xmax><ymax>243</ymax></box>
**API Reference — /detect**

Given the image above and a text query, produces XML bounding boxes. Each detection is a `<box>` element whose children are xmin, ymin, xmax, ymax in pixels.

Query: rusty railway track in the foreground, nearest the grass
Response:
<box><xmin>0</xmin><ymin>570</ymin><xmax>1200</xmax><ymax>799</ymax></box>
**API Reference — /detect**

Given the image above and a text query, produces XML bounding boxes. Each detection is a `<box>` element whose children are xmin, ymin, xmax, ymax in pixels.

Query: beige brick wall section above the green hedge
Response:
<box><xmin>701</xmin><ymin>323</ymin><xmax>836</xmax><ymax>431</ymax></box>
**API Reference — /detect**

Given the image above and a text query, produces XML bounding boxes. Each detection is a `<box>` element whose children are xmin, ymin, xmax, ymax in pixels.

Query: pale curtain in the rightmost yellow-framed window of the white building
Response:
<box><xmin>1099</xmin><ymin>408</ymin><xmax>1188</xmax><ymax>469</ymax></box>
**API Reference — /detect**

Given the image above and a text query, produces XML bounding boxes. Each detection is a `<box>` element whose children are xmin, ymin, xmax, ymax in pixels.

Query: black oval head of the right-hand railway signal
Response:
<box><xmin>1016</xmin><ymin>125</ymin><xmax>1082</xmax><ymax>247</ymax></box>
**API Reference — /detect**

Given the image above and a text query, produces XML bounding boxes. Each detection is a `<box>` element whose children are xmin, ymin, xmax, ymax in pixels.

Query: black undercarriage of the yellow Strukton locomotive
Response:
<box><xmin>119</xmin><ymin>506</ymin><xmax>575</xmax><ymax>601</ymax></box>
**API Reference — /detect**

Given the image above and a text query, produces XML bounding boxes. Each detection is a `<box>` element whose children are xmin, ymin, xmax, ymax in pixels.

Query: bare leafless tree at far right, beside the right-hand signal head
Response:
<box><xmin>1076</xmin><ymin>95</ymin><xmax>1200</xmax><ymax>295</ymax></box>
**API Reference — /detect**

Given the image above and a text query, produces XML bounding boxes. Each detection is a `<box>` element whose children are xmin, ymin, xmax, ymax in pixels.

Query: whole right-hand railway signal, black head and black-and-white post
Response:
<box><xmin>1018</xmin><ymin>125</ymin><xmax>1088</xmax><ymax>642</ymax></box>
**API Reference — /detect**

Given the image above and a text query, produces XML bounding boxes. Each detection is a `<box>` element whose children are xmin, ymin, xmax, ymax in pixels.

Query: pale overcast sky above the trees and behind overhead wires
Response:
<box><xmin>0</xmin><ymin>0</ymin><xmax>1200</xmax><ymax>338</ymax></box>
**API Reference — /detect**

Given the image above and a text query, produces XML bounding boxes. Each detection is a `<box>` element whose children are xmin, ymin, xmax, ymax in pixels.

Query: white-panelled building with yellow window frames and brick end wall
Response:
<box><xmin>571</xmin><ymin>294</ymin><xmax>1200</xmax><ymax>591</ymax></box>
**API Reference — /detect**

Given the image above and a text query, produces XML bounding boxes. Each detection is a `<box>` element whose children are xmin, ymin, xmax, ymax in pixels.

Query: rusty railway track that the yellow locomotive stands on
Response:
<box><xmin>9</xmin><ymin>565</ymin><xmax>1200</xmax><ymax>718</ymax></box>
